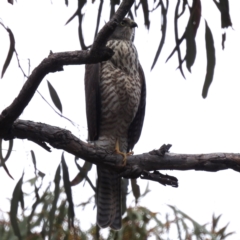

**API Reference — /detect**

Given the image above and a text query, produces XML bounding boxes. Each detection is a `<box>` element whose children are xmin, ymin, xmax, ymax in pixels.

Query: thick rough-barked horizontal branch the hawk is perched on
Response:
<box><xmin>0</xmin><ymin>120</ymin><xmax>240</xmax><ymax>174</ymax></box>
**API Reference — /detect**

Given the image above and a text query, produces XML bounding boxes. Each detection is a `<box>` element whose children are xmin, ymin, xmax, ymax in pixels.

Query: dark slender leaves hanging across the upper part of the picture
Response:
<box><xmin>0</xmin><ymin>0</ymin><xmax>232</xmax><ymax>97</ymax></box>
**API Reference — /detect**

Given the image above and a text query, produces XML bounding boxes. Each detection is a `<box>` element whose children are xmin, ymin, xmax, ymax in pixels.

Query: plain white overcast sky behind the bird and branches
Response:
<box><xmin>0</xmin><ymin>0</ymin><xmax>240</xmax><ymax>239</ymax></box>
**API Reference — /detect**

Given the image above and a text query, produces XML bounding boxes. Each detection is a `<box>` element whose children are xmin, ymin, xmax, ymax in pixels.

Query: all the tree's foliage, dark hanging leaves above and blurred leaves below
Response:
<box><xmin>0</xmin><ymin>0</ymin><xmax>236</xmax><ymax>240</ymax></box>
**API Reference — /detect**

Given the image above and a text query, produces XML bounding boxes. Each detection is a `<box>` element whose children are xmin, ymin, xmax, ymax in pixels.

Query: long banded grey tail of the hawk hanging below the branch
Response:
<box><xmin>97</xmin><ymin>167</ymin><xmax>122</xmax><ymax>230</ymax></box>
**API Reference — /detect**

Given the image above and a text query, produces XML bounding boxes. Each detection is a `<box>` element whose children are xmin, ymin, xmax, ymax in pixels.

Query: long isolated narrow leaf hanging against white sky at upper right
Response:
<box><xmin>202</xmin><ymin>21</ymin><xmax>216</xmax><ymax>98</ymax></box>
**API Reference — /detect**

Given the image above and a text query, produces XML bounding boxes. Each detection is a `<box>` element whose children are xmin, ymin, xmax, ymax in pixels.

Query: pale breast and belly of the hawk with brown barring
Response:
<box><xmin>97</xmin><ymin>40</ymin><xmax>141</xmax><ymax>151</ymax></box>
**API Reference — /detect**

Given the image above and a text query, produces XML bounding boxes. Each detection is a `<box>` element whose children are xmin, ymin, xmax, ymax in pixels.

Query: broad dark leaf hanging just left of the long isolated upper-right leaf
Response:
<box><xmin>185</xmin><ymin>19</ymin><xmax>197</xmax><ymax>72</ymax></box>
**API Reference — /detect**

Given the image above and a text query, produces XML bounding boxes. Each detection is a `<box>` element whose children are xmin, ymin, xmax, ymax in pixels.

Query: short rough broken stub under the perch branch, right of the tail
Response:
<box><xmin>140</xmin><ymin>171</ymin><xmax>178</xmax><ymax>187</ymax></box>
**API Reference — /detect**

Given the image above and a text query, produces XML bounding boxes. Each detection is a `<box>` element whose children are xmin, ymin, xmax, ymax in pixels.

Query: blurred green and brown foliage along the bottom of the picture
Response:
<box><xmin>0</xmin><ymin>164</ymin><xmax>233</xmax><ymax>240</ymax></box>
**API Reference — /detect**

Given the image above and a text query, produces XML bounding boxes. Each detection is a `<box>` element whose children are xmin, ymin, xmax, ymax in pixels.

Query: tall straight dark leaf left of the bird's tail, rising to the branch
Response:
<box><xmin>61</xmin><ymin>153</ymin><xmax>75</xmax><ymax>227</ymax></box>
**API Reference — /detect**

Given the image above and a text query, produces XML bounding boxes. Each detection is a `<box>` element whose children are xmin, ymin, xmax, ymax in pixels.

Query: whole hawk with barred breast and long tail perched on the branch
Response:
<box><xmin>85</xmin><ymin>18</ymin><xmax>146</xmax><ymax>230</ymax></box>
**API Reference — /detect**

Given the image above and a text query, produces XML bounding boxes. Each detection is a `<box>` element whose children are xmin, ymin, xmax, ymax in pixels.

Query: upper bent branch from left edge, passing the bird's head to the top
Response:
<box><xmin>0</xmin><ymin>0</ymin><xmax>134</xmax><ymax>133</ymax></box>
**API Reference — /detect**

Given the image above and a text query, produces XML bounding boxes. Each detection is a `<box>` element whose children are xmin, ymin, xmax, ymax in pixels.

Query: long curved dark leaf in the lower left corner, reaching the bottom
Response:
<box><xmin>10</xmin><ymin>174</ymin><xmax>24</xmax><ymax>240</ymax></box>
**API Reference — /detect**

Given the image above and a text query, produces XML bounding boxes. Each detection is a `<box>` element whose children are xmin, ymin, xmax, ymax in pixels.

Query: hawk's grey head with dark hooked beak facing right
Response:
<box><xmin>110</xmin><ymin>18</ymin><xmax>137</xmax><ymax>41</ymax></box>
